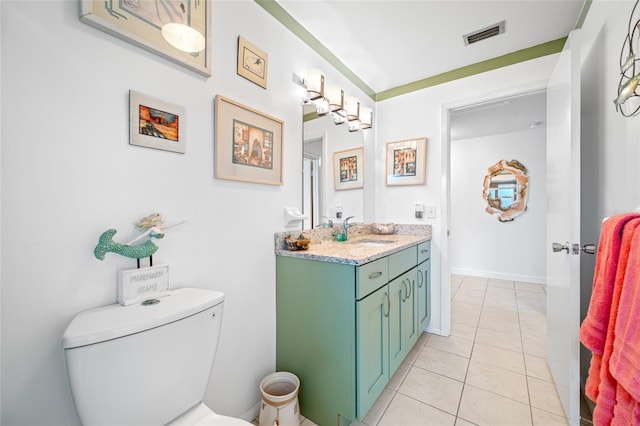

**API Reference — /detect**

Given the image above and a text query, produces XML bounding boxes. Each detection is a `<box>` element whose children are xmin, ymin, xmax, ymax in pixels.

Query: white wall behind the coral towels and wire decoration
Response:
<box><xmin>580</xmin><ymin>0</ymin><xmax>640</xmax><ymax>396</ymax></box>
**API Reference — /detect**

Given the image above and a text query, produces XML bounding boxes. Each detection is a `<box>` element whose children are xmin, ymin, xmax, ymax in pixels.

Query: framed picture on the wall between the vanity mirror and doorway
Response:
<box><xmin>385</xmin><ymin>138</ymin><xmax>427</xmax><ymax>186</ymax></box>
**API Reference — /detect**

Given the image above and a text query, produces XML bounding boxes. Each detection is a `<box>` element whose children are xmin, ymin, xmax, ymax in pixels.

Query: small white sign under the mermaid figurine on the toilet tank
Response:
<box><xmin>118</xmin><ymin>265</ymin><xmax>169</xmax><ymax>306</ymax></box>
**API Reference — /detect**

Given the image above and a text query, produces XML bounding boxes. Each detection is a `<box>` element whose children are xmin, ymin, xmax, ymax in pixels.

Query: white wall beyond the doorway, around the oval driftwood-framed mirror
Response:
<box><xmin>449</xmin><ymin>127</ymin><xmax>547</xmax><ymax>283</ymax></box>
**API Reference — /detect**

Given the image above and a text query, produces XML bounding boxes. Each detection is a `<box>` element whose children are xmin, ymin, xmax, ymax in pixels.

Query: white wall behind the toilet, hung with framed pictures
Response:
<box><xmin>0</xmin><ymin>0</ymin><xmax>372</xmax><ymax>425</ymax></box>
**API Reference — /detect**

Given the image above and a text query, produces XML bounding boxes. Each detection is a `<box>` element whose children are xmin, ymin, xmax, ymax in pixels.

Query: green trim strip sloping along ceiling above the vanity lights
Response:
<box><xmin>255</xmin><ymin>0</ymin><xmax>376</xmax><ymax>100</ymax></box>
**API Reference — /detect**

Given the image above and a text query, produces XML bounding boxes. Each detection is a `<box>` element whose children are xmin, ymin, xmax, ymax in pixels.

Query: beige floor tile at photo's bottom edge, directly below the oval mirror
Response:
<box><xmin>458</xmin><ymin>385</ymin><xmax>531</xmax><ymax>426</ymax></box>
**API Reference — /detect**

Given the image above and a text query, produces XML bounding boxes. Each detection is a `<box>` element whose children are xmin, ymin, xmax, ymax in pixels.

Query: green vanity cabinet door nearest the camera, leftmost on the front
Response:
<box><xmin>356</xmin><ymin>285</ymin><xmax>390</xmax><ymax>418</ymax></box>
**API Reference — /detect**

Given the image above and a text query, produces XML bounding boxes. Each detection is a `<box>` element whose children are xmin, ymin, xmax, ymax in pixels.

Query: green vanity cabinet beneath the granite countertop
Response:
<box><xmin>276</xmin><ymin>241</ymin><xmax>424</xmax><ymax>426</ymax></box>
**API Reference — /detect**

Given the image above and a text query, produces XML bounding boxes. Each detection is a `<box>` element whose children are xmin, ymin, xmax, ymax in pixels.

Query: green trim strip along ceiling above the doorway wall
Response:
<box><xmin>375</xmin><ymin>37</ymin><xmax>567</xmax><ymax>102</ymax></box>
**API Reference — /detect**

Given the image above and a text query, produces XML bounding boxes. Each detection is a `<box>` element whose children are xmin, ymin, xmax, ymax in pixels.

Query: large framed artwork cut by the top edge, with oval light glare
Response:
<box><xmin>80</xmin><ymin>0</ymin><xmax>212</xmax><ymax>77</ymax></box>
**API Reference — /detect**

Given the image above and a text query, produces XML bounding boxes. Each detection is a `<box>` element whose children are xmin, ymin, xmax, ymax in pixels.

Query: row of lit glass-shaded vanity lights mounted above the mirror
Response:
<box><xmin>302</xmin><ymin>69</ymin><xmax>373</xmax><ymax>132</ymax></box>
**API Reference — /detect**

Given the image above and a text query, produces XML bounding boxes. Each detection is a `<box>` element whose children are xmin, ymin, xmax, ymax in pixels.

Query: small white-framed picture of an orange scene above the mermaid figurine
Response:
<box><xmin>129</xmin><ymin>90</ymin><xmax>186</xmax><ymax>154</ymax></box>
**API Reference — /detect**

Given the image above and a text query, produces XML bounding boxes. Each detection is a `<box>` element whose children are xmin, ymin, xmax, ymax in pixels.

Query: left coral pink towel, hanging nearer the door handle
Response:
<box><xmin>580</xmin><ymin>214</ymin><xmax>640</xmax><ymax>402</ymax></box>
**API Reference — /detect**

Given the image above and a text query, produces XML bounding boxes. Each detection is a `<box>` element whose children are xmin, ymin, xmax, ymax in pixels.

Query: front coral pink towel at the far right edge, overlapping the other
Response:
<box><xmin>609</xmin><ymin>223</ymin><xmax>640</xmax><ymax>401</ymax></box>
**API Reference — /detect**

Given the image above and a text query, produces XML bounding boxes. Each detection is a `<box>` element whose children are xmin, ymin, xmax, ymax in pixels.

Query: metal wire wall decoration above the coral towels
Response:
<box><xmin>613</xmin><ymin>1</ymin><xmax>640</xmax><ymax>117</ymax></box>
